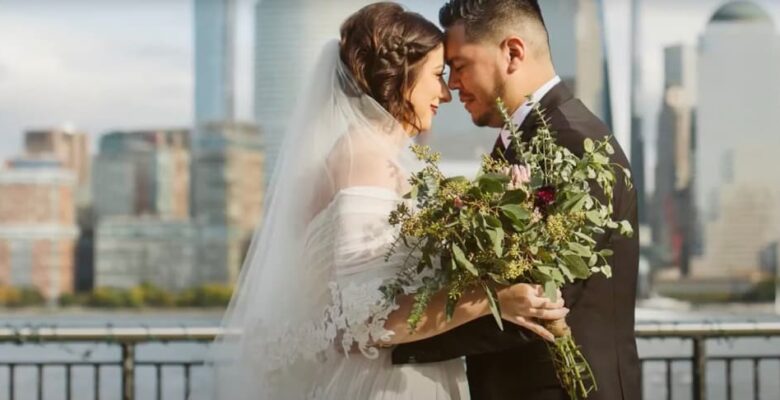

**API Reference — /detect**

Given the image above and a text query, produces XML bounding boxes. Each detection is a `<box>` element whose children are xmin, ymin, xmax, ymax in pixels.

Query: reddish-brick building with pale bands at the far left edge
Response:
<box><xmin>0</xmin><ymin>158</ymin><xmax>79</xmax><ymax>300</ymax></box>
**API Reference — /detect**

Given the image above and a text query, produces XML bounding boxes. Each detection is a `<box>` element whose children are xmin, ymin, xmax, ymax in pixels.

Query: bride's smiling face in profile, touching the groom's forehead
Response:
<box><xmin>409</xmin><ymin>45</ymin><xmax>452</xmax><ymax>132</ymax></box>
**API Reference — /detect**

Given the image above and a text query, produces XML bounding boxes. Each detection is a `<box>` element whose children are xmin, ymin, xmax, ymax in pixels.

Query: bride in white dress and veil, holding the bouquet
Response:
<box><xmin>201</xmin><ymin>3</ymin><xmax>567</xmax><ymax>400</ymax></box>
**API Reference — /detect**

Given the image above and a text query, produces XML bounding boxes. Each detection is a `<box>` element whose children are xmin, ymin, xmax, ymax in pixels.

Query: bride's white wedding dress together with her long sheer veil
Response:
<box><xmin>201</xmin><ymin>41</ymin><xmax>469</xmax><ymax>400</ymax></box>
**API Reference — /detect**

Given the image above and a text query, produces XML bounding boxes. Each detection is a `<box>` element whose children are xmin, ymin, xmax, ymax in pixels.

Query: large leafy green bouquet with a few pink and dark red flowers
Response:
<box><xmin>384</xmin><ymin>99</ymin><xmax>633</xmax><ymax>399</ymax></box>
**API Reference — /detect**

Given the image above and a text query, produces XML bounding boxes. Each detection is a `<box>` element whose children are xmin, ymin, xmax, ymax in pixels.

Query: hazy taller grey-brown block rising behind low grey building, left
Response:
<box><xmin>93</xmin><ymin>129</ymin><xmax>190</xmax><ymax>220</ymax></box>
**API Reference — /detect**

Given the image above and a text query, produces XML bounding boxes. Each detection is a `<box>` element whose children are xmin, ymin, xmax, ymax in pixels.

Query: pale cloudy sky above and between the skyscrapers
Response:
<box><xmin>0</xmin><ymin>0</ymin><xmax>780</xmax><ymax>193</ymax></box>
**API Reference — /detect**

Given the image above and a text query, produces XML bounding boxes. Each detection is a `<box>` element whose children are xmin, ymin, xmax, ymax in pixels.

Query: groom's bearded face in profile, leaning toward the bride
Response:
<box><xmin>445</xmin><ymin>24</ymin><xmax>505</xmax><ymax>128</ymax></box>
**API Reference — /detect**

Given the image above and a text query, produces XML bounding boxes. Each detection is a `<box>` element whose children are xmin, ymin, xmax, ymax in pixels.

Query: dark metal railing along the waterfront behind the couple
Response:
<box><xmin>0</xmin><ymin>322</ymin><xmax>780</xmax><ymax>400</ymax></box>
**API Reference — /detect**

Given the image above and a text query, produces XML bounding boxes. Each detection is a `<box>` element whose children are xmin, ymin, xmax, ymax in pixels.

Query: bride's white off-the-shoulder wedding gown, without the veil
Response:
<box><xmin>307</xmin><ymin>186</ymin><xmax>468</xmax><ymax>400</ymax></box>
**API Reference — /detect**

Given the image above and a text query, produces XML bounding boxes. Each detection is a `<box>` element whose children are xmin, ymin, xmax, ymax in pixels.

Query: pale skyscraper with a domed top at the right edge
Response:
<box><xmin>695</xmin><ymin>1</ymin><xmax>780</xmax><ymax>274</ymax></box>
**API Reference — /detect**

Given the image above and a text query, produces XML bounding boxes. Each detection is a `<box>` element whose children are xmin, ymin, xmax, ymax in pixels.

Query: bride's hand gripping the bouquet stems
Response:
<box><xmin>497</xmin><ymin>283</ymin><xmax>569</xmax><ymax>341</ymax></box>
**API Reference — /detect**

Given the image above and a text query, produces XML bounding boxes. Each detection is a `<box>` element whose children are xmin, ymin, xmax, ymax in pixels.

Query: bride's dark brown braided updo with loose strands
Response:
<box><xmin>340</xmin><ymin>2</ymin><xmax>444</xmax><ymax>130</ymax></box>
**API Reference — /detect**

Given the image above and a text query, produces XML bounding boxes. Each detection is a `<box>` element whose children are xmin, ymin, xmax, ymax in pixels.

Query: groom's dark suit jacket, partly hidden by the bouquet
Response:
<box><xmin>393</xmin><ymin>83</ymin><xmax>641</xmax><ymax>400</ymax></box>
